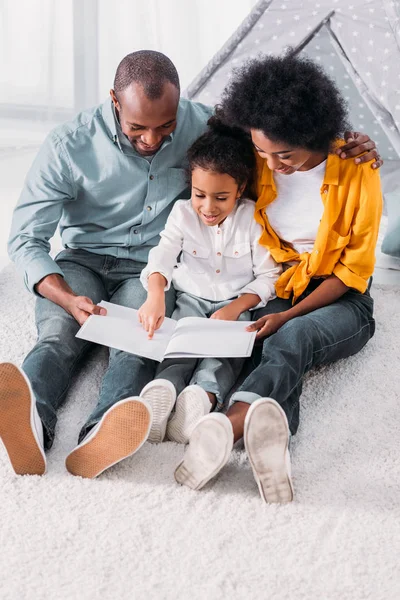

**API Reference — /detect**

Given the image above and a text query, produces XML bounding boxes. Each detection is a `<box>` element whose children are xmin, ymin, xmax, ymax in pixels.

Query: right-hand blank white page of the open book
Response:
<box><xmin>165</xmin><ymin>317</ymin><xmax>256</xmax><ymax>358</ymax></box>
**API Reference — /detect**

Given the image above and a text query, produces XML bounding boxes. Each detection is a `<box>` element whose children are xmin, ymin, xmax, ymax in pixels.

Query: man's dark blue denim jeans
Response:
<box><xmin>22</xmin><ymin>250</ymin><xmax>175</xmax><ymax>449</ymax></box>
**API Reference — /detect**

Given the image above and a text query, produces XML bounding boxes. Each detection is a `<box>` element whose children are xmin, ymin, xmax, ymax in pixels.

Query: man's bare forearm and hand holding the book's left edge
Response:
<box><xmin>36</xmin><ymin>273</ymin><xmax>107</xmax><ymax>325</ymax></box>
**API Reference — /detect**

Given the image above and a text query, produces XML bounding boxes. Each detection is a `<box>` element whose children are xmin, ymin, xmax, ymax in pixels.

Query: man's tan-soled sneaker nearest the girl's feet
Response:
<box><xmin>65</xmin><ymin>397</ymin><xmax>152</xmax><ymax>479</ymax></box>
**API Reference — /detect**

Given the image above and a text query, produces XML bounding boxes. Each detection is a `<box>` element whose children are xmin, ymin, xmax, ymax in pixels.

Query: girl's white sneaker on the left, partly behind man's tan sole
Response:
<box><xmin>140</xmin><ymin>379</ymin><xmax>176</xmax><ymax>444</ymax></box>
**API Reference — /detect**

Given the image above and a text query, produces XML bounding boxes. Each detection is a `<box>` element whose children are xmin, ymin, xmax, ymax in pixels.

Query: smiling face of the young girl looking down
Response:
<box><xmin>192</xmin><ymin>167</ymin><xmax>245</xmax><ymax>227</ymax></box>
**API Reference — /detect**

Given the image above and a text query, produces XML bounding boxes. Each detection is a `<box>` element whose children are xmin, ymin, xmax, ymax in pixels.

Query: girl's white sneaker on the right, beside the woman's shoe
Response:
<box><xmin>167</xmin><ymin>385</ymin><xmax>212</xmax><ymax>444</ymax></box>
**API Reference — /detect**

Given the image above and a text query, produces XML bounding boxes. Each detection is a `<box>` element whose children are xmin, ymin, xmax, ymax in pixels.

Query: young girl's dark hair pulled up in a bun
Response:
<box><xmin>187</xmin><ymin>108</ymin><xmax>256</xmax><ymax>194</ymax></box>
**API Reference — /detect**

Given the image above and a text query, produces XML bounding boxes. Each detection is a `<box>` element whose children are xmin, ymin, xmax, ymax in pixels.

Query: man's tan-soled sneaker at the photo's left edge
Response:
<box><xmin>0</xmin><ymin>363</ymin><xmax>46</xmax><ymax>475</ymax></box>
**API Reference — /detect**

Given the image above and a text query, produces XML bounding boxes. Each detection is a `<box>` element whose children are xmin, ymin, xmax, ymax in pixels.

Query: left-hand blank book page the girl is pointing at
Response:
<box><xmin>76</xmin><ymin>300</ymin><xmax>176</xmax><ymax>362</ymax></box>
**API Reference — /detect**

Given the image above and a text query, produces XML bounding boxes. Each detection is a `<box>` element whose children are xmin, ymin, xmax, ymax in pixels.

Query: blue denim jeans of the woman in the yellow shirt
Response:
<box><xmin>231</xmin><ymin>281</ymin><xmax>375</xmax><ymax>435</ymax></box>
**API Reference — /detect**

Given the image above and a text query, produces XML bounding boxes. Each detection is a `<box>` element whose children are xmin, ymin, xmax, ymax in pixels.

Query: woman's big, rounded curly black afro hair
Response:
<box><xmin>221</xmin><ymin>52</ymin><xmax>349</xmax><ymax>153</ymax></box>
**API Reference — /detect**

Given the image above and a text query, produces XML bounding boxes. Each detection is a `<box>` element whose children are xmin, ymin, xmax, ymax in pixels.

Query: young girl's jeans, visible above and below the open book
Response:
<box><xmin>156</xmin><ymin>292</ymin><xmax>251</xmax><ymax>409</ymax></box>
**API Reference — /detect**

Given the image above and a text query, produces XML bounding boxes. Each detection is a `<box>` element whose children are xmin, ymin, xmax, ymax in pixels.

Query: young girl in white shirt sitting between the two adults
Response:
<box><xmin>139</xmin><ymin>117</ymin><xmax>281</xmax><ymax>443</ymax></box>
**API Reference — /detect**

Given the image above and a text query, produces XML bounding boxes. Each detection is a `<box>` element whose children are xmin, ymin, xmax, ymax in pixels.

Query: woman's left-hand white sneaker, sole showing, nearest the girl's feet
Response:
<box><xmin>175</xmin><ymin>413</ymin><xmax>233</xmax><ymax>490</ymax></box>
